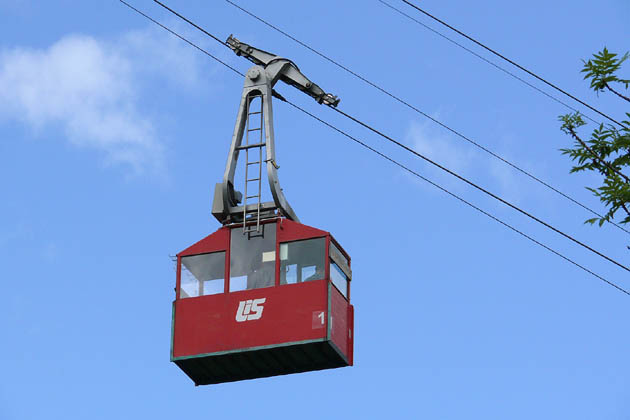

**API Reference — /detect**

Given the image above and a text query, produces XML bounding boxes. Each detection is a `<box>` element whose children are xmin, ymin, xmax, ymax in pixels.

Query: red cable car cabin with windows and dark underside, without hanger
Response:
<box><xmin>171</xmin><ymin>218</ymin><xmax>354</xmax><ymax>385</ymax></box>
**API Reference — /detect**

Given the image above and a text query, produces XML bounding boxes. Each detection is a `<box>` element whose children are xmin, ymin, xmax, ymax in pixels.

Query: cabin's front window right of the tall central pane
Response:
<box><xmin>280</xmin><ymin>238</ymin><xmax>326</xmax><ymax>284</ymax></box>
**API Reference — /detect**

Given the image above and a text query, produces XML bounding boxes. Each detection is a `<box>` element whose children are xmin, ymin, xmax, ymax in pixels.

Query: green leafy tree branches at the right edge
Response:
<box><xmin>559</xmin><ymin>48</ymin><xmax>630</xmax><ymax>226</ymax></box>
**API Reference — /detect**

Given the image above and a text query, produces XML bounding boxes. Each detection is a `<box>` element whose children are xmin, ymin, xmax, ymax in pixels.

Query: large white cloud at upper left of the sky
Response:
<box><xmin>0</xmin><ymin>30</ymin><xmax>210</xmax><ymax>171</ymax></box>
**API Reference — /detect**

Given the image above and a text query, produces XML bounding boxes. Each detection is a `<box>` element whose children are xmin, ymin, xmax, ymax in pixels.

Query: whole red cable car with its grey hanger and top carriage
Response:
<box><xmin>171</xmin><ymin>36</ymin><xmax>354</xmax><ymax>385</ymax></box>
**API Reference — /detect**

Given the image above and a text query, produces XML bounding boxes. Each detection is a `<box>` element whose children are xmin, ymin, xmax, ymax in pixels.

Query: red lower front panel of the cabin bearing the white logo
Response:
<box><xmin>173</xmin><ymin>280</ymin><xmax>328</xmax><ymax>358</ymax></box>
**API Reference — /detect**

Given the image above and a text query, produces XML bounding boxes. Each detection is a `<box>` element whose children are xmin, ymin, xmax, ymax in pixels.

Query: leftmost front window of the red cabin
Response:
<box><xmin>179</xmin><ymin>252</ymin><xmax>225</xmax><ymax>299</ymax></box>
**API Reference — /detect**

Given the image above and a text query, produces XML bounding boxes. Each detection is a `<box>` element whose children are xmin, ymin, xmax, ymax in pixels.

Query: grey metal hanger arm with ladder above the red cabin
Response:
<box><xmin>212</xmin><ymin>35</ymin><xmax>339</xmax><ymax>233</ymax></box>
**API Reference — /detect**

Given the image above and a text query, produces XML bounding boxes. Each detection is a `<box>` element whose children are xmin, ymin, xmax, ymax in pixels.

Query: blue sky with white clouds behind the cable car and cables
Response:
<box><xmin>0</xmin><ymin>0</ymin><xmax>630</xmax><ymax>419</ymax></box>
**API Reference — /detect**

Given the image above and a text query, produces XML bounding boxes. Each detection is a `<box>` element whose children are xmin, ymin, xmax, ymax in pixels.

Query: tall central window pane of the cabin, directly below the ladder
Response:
<box><xmin>230</xmin><ymin>223</ymin><xmax>276</xmax><ymax>292</ymax></box>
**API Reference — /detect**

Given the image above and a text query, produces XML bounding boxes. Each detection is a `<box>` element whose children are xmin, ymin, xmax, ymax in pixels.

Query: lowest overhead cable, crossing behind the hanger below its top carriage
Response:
<box><xmin>119</xmin><ymin>0</ymin><xmax>630</xmax><ymax>296</ymax></box>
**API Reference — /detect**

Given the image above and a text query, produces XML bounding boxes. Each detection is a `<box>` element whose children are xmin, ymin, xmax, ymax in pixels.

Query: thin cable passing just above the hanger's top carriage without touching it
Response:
<box><xmin>222</xmin><ymin>0</ymin><xmax>630</xmax><ymax>234</ymax></box>
